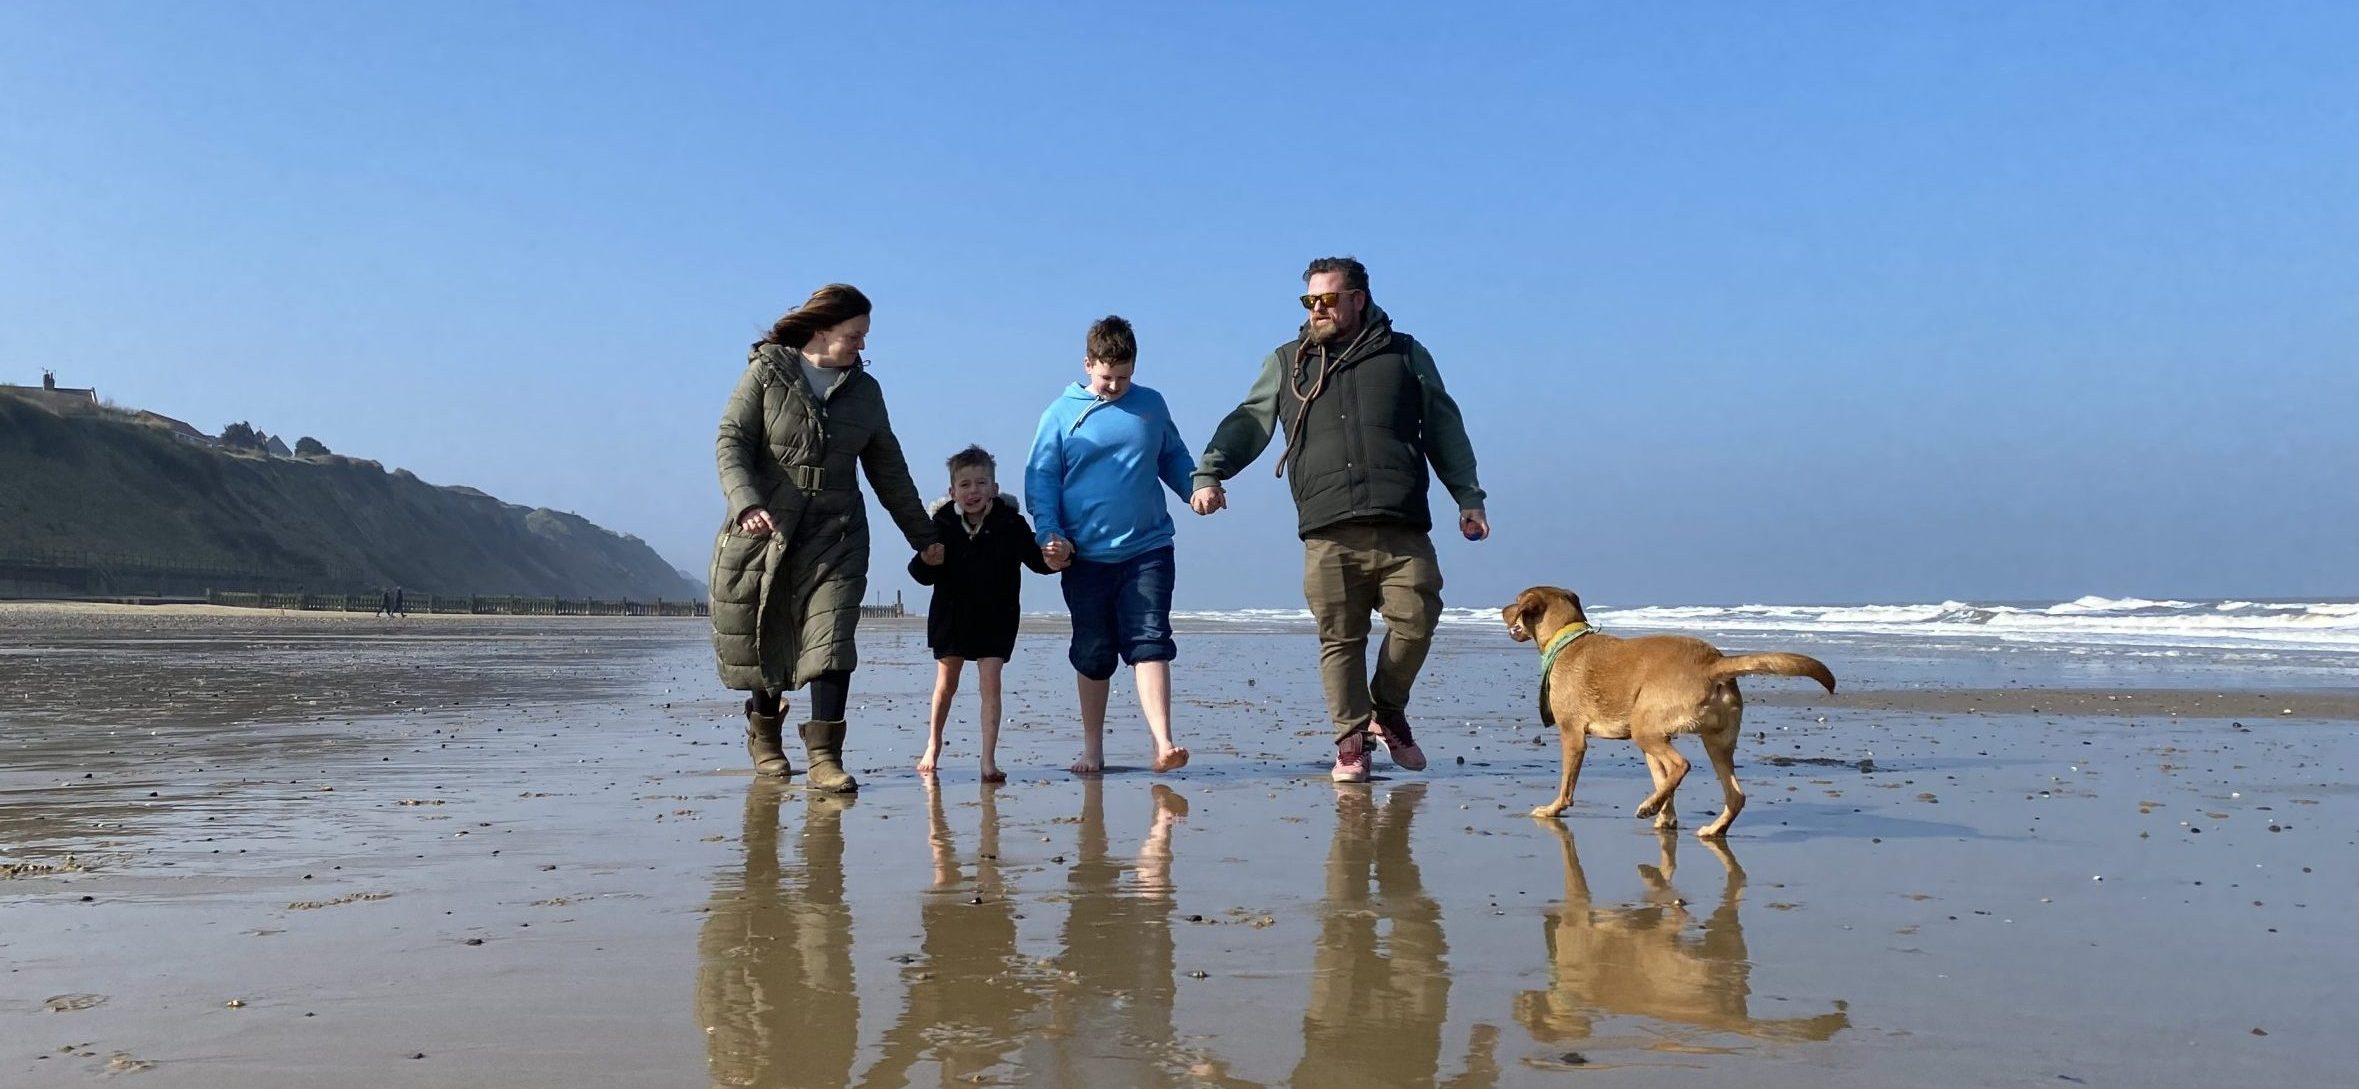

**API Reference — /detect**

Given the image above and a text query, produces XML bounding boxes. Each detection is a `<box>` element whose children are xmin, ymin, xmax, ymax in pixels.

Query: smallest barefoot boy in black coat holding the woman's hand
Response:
<box><xmin>908</xmin><ymin>446</ymin><xmax>1052</xmax><ymax>783</ymax></box>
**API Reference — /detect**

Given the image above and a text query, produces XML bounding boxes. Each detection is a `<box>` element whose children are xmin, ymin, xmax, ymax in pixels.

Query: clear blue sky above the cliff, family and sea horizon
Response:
<box><xmin>0</xmin><ymin>2</ymin><xmax>2359</xmax><ymax>608</ymax></box>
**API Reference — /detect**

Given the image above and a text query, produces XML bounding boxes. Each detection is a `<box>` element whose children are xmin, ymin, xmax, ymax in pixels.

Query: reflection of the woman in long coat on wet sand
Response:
<box><xmin>696</xmin><ymin>780</ymin><xmax>861</xmax><ymax>1089</ymax></box>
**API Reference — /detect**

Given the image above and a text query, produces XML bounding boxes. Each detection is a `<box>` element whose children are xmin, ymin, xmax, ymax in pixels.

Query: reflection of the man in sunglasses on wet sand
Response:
<box><xmin>1288</xmin><ymin>783</ymin><xmax>1498</xmax><ymax>1089</ymax></box>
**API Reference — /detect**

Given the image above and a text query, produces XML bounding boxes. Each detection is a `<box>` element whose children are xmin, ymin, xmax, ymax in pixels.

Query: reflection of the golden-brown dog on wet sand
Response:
<box><xmin>1514</xmin><ymin>820</ymin><xmax>1852</xmax><ymax>1047</ymax></box>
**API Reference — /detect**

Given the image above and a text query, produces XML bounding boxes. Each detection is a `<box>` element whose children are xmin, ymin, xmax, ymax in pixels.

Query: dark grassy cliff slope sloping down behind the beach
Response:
<box><xmin>0</xmin><ymin>394</ymin><xmax>701</xmax><ymax>601</ymax></box>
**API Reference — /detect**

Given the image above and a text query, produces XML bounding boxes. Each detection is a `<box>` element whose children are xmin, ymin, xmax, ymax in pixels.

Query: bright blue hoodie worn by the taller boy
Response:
<box><xmin>1024</xmin><ymin>382</ymin><xmax>1196</xmax><ymax>563</ymax></box>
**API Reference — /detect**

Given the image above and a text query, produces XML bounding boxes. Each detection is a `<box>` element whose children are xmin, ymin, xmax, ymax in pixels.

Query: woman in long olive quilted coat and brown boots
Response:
<box><xmin>712</xmin><ymin>283</ymin><xmax>941</xmax><ymax>794</ymax></box>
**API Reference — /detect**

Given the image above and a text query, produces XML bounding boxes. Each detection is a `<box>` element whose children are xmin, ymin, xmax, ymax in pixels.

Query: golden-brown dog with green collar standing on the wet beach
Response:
<box><xmin>1500</xmin><ymin>587</ymin><xmax>1835</xmax><ymax>839</ymax></box>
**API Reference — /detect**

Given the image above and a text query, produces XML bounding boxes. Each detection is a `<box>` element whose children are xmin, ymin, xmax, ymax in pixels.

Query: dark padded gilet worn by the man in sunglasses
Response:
<box><xmin>1279</xmin><ymin>323</ymin><xmax>1434</xmax><ymax>537</ymax></box>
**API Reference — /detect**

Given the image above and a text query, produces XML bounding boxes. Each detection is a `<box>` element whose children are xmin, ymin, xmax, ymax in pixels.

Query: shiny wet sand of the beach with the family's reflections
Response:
<box><xmin>0</xmin><ymin>611</ymin><xmax>2359</xmax><ymax>1089</ymax></box>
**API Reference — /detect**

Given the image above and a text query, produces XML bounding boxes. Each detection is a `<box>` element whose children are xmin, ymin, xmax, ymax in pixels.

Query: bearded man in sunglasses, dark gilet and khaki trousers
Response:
<box><xmin>1189</xmin><ymin>257</ymin><xmax>1491</xmax><ymax>783</ymax></box>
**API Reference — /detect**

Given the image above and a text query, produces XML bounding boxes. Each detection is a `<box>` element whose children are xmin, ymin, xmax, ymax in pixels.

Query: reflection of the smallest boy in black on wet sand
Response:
<box><xmin>859</xmin><ymin>780</ymin><xmax>1045</xmax><ymax>1089</ymax></box>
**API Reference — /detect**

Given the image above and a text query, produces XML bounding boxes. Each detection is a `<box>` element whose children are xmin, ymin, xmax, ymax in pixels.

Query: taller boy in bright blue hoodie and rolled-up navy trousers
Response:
<box><xmin>1024</xmin><ymin>318</ymin><xmax>1196</xmax><ymax>776</ymax></box>
